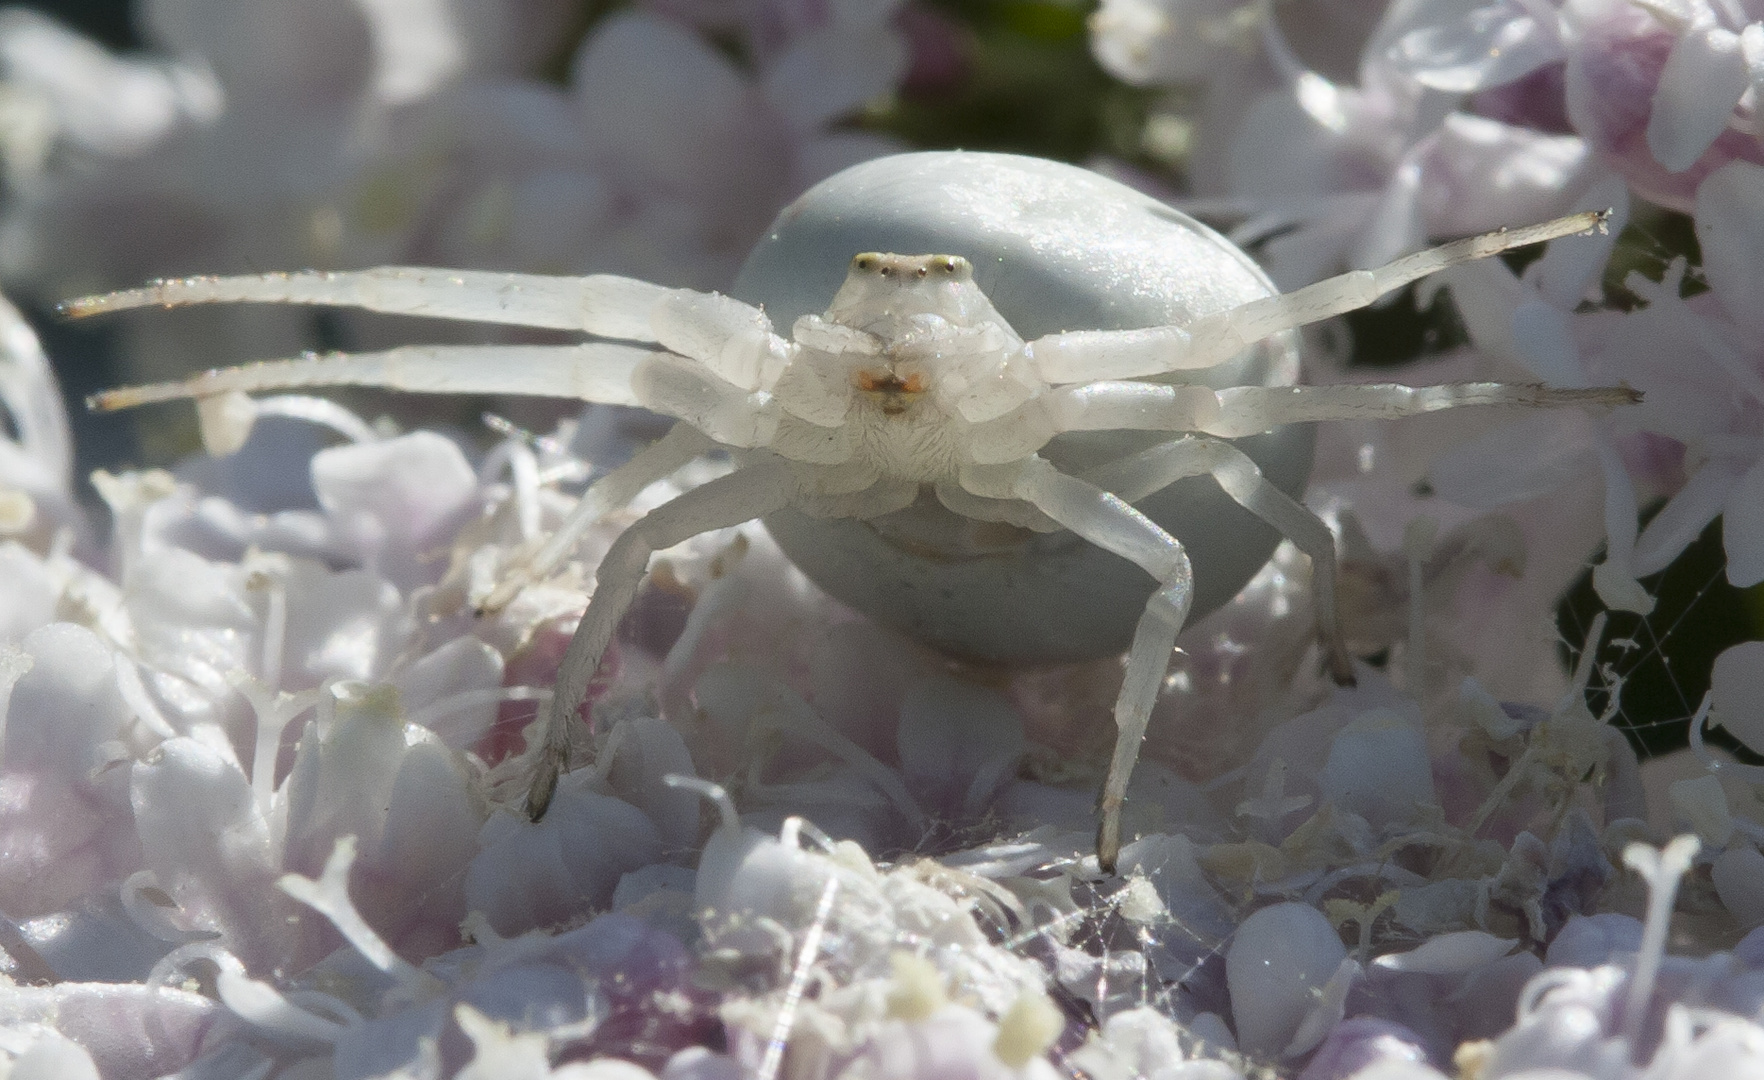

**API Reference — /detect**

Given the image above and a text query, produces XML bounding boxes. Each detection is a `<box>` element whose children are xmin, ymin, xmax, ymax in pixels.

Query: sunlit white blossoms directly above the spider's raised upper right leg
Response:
<box><xmin>1092</xmin><ymin>4</ymin><xmax>1602</xmax><ymax>288</ymax></box>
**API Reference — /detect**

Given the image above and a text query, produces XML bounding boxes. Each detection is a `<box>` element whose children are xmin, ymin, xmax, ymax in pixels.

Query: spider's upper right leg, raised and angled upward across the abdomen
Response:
<box><xmin>1025</xmin><ymin>212</ymin><xmax>1607</xmax><ymax>383</ymax></box>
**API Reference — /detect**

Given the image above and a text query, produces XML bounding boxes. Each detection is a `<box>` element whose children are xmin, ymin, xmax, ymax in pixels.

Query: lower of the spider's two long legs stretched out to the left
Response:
<box><xmin>86</xmin><ymin>342</ymin><xmax>665</xmax><ymax>411</ymax></box>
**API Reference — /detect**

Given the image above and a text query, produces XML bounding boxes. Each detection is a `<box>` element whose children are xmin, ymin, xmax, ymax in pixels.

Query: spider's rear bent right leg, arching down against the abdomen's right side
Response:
<box><xmin>1083</xmin><ymin>436</ymin><xmax>1353</xmax><ymax>686</ymax></box>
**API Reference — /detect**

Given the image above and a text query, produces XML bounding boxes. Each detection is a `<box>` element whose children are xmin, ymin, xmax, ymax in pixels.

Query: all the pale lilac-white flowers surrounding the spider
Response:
<box><xmin>0</xmin><ymin>0</ymin><xmax>1764</xmax><ymax>1080</ymax></box>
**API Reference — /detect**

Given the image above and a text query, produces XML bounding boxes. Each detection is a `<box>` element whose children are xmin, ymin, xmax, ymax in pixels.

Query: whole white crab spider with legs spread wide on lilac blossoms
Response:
<box><xmin>65</xmin><ymin>154</ymin><xmax>1635</xmax><ymax>866</ymax></box>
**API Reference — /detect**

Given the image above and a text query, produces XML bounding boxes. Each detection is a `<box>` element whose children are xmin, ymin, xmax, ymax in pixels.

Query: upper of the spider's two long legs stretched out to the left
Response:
<box><xmin>60</xmin><ymin>266</ymin><xmax>681</xmax><ymax>341</ymax></box>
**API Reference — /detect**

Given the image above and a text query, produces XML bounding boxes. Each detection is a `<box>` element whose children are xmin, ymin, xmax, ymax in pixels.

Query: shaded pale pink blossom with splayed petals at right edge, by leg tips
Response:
<box><xmin>1434</xmin><ymin>162</ymin><xmax>1764</xmax><ymax>611</ymax></box>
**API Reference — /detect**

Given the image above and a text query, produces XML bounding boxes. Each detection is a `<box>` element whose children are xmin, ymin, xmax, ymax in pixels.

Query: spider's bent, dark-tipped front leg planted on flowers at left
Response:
<box><xmin>527</xmin><ymin>461</ymin><xmax>796</xmax><ymax>821</ymax></box>
